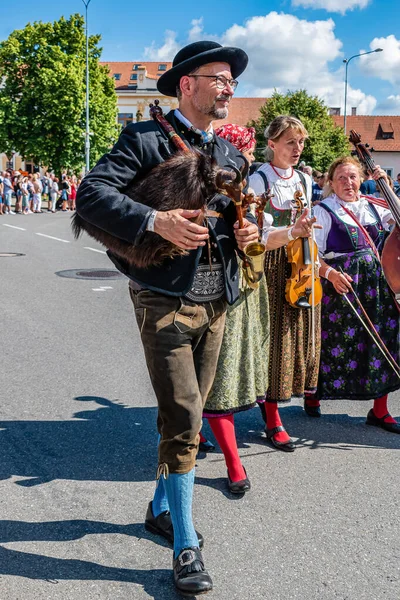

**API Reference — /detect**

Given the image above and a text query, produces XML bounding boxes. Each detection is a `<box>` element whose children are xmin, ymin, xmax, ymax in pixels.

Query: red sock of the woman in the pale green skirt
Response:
<box><xmin>208</xmin><ymin>415</ymin><xmax>246</xmax><ymax>481</ymax></box>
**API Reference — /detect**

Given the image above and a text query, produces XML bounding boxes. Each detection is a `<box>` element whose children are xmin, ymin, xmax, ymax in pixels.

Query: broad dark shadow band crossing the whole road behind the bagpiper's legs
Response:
<box><xmin>0</xmin><ymin>396</ymin><xmax>400</xmax><ymax>488</ymax></box>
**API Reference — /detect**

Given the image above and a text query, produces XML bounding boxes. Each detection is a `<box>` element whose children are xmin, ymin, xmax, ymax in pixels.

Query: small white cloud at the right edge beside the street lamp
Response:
<box><xmin>360</xmin><ymin>35</ymin><xmax>400</xmax><ymax>85</ymax></box>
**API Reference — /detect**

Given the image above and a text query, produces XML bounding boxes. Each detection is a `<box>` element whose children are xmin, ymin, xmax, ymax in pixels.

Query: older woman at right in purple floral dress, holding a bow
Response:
<box><xmin>315</xmin><ymin>157</ymin><xmax>400</xmax><ymax>433</ymax></box>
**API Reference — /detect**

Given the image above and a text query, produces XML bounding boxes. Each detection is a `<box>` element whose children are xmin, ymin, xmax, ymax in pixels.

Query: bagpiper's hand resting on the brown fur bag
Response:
<box><xmin>154</xmin><ymin>208</ymin><xmax>209</xmax><ymax>250</ymax></box>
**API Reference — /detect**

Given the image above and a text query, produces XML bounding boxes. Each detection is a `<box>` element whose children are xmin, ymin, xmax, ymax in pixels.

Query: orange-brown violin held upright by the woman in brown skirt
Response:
<box><xmin>285</xmin><ymin>191</ymin><xmax>322</xmax><ymax>308</ymax></box>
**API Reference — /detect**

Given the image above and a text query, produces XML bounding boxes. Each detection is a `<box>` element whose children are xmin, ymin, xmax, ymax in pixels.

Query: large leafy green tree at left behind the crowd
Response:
<box><xmin>0</xmin><ymin>14</ymin><xmax>119</xmax><ymax>173</ymax></box>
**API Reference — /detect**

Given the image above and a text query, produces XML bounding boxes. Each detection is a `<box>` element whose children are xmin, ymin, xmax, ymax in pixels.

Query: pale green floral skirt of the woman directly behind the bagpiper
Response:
<box><xmin>203</xmin><ymin>268</ymin><xmax>269</xmax><ymax>417</ymax></box>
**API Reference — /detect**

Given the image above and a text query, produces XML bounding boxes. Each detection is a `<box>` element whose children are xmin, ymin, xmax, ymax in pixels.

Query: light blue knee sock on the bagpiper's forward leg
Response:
<box><xmin>164</xmin><ymin>469</ymin><xmax>199</xmax><ymax>558</ymax></box>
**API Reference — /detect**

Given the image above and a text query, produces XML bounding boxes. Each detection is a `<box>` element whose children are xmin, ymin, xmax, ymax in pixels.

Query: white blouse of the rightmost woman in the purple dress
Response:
<box><xmin>314</xmin><ymin>194</ymin><xmax>393</xmax><ymax>258</ymax></box>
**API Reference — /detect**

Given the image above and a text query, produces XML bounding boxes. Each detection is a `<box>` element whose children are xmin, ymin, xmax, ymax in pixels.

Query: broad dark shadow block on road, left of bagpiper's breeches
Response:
<box><xmin>0</xmin><ymin>396</ymin><xmax>157</xmax><ymax>487</ymax></box>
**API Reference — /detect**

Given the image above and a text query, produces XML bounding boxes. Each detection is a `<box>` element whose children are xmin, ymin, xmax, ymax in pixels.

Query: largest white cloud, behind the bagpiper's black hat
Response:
<box><xmin>146</xmin><ymin>12</ymin><xmax>376</xmax><ymax>114</ymax></box>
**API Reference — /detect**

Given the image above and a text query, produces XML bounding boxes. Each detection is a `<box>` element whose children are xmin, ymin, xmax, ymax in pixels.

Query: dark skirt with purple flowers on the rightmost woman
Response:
<box><xmin>317</xmin><ymin>249</ymin><xmax>400</xmax><ymax>400</ymax></box>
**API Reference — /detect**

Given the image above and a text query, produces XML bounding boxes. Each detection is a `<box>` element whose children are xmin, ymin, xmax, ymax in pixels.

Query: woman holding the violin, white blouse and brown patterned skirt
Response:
<box><xmin>250</xmin><ymin>115</ymin><xmax>320</xmax><ymax>452</ymax></box>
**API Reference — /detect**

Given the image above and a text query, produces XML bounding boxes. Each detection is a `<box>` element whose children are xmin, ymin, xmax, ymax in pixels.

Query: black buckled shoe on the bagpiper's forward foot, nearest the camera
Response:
<box><xmin>172</xmin><ymin>548</ymin><xmax>213</xmax><ymax>596</ymax></box>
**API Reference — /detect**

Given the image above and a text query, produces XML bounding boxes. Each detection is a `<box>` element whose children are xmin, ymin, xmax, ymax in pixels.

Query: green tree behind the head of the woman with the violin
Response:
<box><xmin>250</xmin><ymin>90</ymin><xmax>350</xmax><ymax>172</ymax></box>
